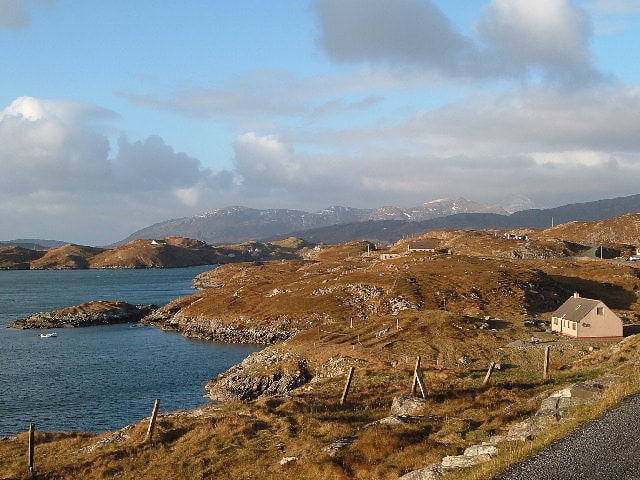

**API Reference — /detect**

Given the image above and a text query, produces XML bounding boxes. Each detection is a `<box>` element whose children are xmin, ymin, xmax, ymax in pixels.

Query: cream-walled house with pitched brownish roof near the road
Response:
<box><xmin>551</xmin><ymin>293</ymin><xmax>622</xmax><ymax>338</ymax></box>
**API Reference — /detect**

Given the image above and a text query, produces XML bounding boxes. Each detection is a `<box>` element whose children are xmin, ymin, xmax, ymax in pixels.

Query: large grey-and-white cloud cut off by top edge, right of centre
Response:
<box><xmin>315</xmin><ymin>0</ymin><xmax>602</xmax><ymax>83</ymax></box>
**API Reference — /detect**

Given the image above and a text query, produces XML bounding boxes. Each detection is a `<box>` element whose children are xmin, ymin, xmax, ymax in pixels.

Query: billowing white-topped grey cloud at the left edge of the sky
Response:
<box><xmin>0</xmin><ymin>97</ymin><xmax>230</xmax><ymax>246</ymax></box>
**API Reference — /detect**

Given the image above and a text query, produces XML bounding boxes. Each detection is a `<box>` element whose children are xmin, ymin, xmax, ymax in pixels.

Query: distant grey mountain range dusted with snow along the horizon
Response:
<box><xmin>118</xmin><ymin>194</ymin><xmax>640</xmax><ymax>248</ymax></box>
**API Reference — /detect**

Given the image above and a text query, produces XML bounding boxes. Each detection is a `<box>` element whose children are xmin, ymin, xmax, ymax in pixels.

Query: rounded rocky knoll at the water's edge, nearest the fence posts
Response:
<box><xmin>205</xmin><ymin>349</ymin><xmax>311</xmax><ymax>401</ymax></box>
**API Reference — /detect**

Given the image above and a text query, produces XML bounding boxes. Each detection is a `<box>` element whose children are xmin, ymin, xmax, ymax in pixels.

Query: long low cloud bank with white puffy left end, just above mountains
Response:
<box><xmin>225</xmin><ymin>130</ymin><xmax>640</xmax><ymax>213</ymax></box>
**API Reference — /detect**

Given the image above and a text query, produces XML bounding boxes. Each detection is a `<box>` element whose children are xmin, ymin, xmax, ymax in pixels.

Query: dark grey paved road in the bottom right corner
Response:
<box><xmin>494</xmin><ymin>394</ymin><xmax>640</xmax><ymax>480</ymax></box>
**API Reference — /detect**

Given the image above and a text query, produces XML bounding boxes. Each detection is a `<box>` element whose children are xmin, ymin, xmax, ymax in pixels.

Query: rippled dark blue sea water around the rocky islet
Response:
<box><xmin>0</xmin><ymin>266</ymin><xmax>259</xmax><ymax>436</ymax></box>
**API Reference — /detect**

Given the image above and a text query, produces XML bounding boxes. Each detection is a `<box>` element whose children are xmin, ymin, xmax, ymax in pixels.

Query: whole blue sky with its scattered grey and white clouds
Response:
<box><xmin>0</xmin><ymin>0</ymin><xmax>640</xmax><ymax>245</ymax></box>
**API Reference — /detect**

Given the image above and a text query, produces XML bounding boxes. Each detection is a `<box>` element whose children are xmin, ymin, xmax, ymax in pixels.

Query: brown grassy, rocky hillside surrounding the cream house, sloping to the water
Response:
<box><xmin>0</xmin><ymin>215</ymin><xmax>640</xmax><ymax>480</ymax></box>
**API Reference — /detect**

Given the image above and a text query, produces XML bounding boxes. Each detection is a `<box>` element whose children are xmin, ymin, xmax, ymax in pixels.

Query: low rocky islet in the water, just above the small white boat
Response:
<box><xmin>8</xmin><ymin>300</ymin><xmax>157</xmax><ymax>329</ymax></box>
